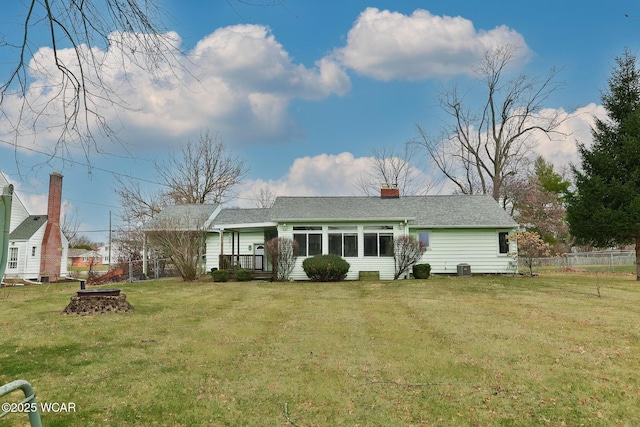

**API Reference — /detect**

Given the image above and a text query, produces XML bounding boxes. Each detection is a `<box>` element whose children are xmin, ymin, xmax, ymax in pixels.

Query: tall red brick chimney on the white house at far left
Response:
<box><xmin>40</xmin><ymin>172</ymin><xmax>63</xmax><ymax>282</ymax></box>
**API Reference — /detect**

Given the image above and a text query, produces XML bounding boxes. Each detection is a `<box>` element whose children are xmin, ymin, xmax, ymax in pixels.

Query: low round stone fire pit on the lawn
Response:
<box><xmin>62</xmin><ymin>288</ymin><xmax>134</xmax><ymax>315</ymax></box>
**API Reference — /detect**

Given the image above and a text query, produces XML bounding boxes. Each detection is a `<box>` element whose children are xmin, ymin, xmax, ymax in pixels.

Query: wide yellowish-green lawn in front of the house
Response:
<box><xmin>0</xmin><ymin>274</ymin><xmax>640</xmax><ymax>427</ymax></box>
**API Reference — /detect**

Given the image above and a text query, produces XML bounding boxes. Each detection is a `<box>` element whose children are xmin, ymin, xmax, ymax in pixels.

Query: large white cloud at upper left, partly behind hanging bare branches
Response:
<box><xmin>0</xmin><ymin>25</ymin><xmax>351</xmax><ymax>154</ymax></box>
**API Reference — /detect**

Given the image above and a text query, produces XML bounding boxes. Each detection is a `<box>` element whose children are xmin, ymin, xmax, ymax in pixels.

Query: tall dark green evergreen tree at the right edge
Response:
<box><xmin>567</xmin><ymin>50</ymin><xmax>640</xmax><ymax>280</ymax></box>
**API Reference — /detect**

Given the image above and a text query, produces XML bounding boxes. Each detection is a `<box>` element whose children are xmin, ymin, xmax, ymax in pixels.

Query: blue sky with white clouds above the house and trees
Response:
<box><xmin>0</xmin><ymin>0</ymin><xmax>640</xmax><ymax>241</ymax></box>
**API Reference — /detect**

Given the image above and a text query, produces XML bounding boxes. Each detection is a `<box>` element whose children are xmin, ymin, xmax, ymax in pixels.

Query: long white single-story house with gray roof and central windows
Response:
<box><xmin>201</xmin><ymin>189</ymin><xmax>518</xmax><ymax>280</ymax></box>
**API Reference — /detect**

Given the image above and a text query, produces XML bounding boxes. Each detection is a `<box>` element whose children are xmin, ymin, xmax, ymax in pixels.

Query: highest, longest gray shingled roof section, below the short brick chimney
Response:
<box><xmin>270</xmin><ymin>195</ymin><xmax>518</xmax><ymax>228</ymax></box>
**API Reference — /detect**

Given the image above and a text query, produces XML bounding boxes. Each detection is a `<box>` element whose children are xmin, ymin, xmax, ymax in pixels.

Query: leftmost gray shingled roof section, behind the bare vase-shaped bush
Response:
<box><xmin>143</xmin><ymin>204</ymin><xmax>219</xmax><ymax>231</ymax></box>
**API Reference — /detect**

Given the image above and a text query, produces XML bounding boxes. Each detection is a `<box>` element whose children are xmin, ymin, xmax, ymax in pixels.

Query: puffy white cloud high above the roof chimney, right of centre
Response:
<box><xmin>335</xmin><ymin>8</ymin><xmax>529</xmax><ymax>81</ymax></box>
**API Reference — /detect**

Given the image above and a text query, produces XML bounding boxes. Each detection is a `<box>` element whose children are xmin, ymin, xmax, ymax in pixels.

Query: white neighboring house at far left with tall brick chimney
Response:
<box><xmin>0</xmin><ymin>172</ymin><xmax>69</xmax><ymax>281</ymax></box>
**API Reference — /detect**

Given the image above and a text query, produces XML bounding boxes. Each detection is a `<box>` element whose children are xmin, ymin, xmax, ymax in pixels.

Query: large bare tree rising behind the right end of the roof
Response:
<box><xmin>417</xmin><ymin>45</ymin><xmax>563</xmax><ymax>205</ymax></box>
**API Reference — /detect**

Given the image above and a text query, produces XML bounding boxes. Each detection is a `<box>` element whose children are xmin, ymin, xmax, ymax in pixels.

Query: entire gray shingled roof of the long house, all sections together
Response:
<box><xmin>158</xmin><ymin>195</ymin><xmax>518</xmax><ymax>231</ymax></box>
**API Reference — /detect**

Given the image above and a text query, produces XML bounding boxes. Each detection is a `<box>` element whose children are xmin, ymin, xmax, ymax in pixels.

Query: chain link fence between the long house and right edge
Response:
<box><xmin>518</xmin><ymin>251</ymin><xmax>636</xmax><ymax>273</ymax></box>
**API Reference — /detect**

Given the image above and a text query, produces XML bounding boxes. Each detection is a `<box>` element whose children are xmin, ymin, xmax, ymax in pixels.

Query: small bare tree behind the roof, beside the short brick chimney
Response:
<box><xmin>355</xmin><ymin>144</ymin><xmax>433</xmax><ymax>196</ymax></box>
